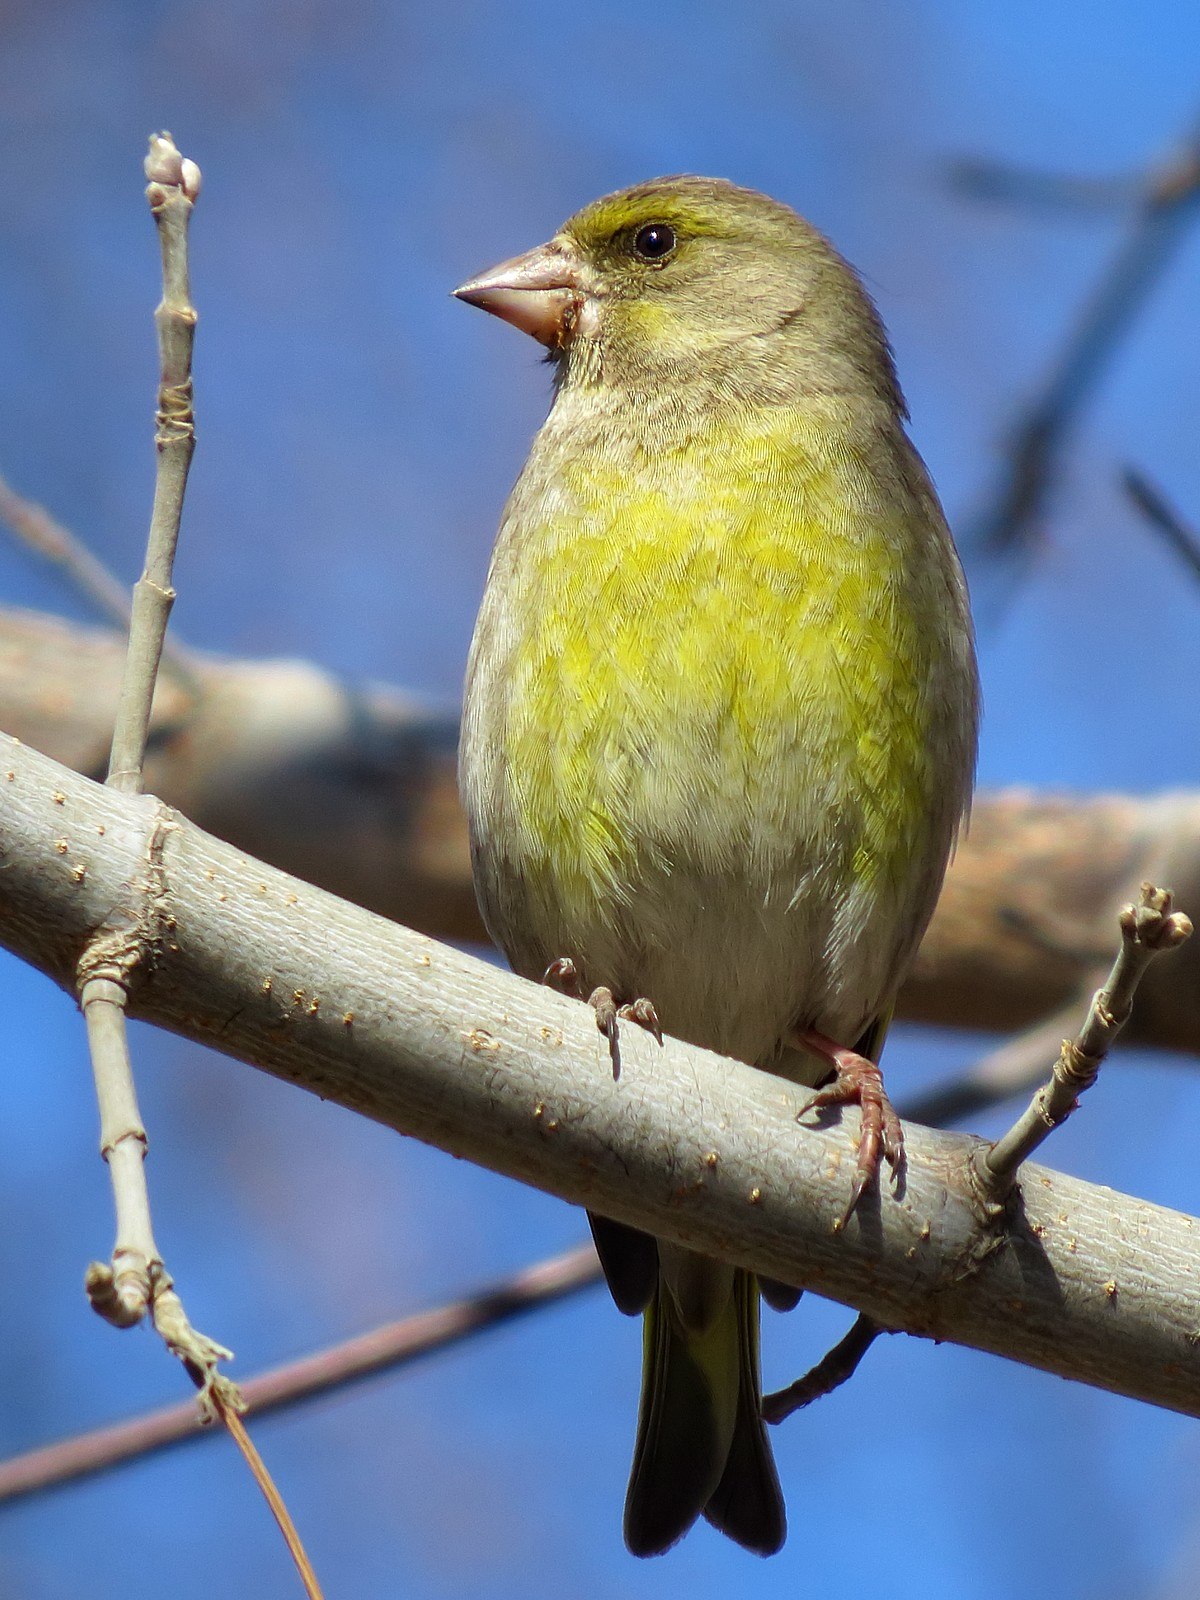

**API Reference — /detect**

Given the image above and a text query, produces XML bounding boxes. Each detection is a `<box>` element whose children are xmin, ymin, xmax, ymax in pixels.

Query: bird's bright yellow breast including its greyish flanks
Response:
<box><xmin>462</xmin><ymin>393</ymin><xmax>970</xmax><ymax>1043</ymax></box>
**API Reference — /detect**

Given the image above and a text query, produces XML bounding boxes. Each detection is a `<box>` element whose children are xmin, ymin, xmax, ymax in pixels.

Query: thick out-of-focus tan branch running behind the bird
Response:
<box><xmin>0</xmin><ymin>610</ymin><xmax>1200</xmax><ymax>1053</ymax></box>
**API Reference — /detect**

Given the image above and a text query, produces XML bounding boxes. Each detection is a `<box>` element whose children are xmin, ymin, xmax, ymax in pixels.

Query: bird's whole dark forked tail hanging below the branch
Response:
<box><xmin>626</xmin><ymin>1270</ymin><xmax>787</xmax><ymax>1555</ymax></box>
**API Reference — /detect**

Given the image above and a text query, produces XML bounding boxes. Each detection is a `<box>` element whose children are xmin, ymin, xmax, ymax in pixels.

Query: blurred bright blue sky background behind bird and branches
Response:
<box><xmin>0</xmin><ymin>0</ymin><xmax>1200</xmax><ymax>1600</ymax></box>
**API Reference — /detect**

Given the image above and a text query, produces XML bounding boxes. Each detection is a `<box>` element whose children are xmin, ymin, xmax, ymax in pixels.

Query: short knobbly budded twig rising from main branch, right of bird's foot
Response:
<box><xmin>976</xmin><ymin>883</ymin><xmax>1192</xmax><ymax>1192</ymax></box>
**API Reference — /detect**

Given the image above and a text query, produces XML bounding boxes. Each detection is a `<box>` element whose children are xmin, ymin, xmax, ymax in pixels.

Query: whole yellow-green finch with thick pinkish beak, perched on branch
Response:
<box><xmin>456</xmin><ymin>178</ymin><xmax>978</xmax><ymax>1555</ymax></box>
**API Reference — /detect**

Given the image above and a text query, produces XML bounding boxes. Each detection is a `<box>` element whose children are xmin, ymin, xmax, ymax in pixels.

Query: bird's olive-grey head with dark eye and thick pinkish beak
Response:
<box><xmin>454</xmin><ymin>178</ymin><xmax>902</xmax><ymax>410</ymax></box>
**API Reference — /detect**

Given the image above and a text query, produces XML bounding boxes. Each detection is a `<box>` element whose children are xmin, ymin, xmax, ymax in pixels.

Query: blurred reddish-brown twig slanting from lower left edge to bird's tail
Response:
<box><xmin>0</xmin><ymin>1243</ymin><xmax>602</xmax><ymax>1504</ymax></box>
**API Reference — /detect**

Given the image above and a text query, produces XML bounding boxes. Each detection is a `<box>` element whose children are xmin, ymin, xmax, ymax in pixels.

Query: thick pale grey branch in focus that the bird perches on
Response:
<box><xmin>0</xmin><ymin>742</ymin><xmax>1200</xmax><ymax>1414</ymax></box>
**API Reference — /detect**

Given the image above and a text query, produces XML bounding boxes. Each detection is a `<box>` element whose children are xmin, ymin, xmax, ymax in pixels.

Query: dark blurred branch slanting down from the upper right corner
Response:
<box><xmin>965</xmin><ymin>118</ymin><xmax>1200</xmax><ymax>554</ymax></box>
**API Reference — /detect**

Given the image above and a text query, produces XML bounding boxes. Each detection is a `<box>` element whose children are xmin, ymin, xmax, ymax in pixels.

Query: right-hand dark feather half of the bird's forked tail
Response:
<box><xmin>704</xmin><ymin>1272</ymin><xmax>787</xmax><ymax>1555</ymax></box>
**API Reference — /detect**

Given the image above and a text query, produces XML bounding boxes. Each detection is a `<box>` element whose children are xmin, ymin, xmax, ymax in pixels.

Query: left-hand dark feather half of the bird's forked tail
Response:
<box><xmin>626</xmin><ymin>1285</ymin><xmax>734</xmax><ymax>1555</ymax></box>
